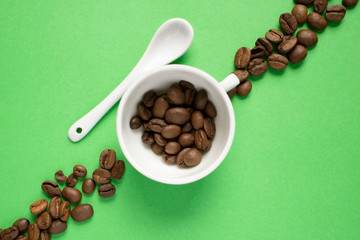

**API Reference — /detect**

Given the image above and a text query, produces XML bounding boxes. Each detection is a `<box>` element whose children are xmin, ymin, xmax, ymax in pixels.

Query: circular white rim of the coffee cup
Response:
<box><xmin>116</xmin><ymin>64</ymin><xmax>235</xmax><ymax>185</ymax></box>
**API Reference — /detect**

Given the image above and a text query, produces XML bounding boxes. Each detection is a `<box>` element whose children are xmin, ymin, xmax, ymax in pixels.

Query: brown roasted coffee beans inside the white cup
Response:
<box><xmin>129</xmin><ymin>80</ymin><xmax>217</xmax><ymax>168</ymax></box>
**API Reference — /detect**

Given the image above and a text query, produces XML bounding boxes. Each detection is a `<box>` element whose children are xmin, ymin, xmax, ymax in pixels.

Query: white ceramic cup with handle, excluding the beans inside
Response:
<box><xmin>116</xmin><ymin>64</ymin><xmax>239</xmax><ymax>184</ymax></box>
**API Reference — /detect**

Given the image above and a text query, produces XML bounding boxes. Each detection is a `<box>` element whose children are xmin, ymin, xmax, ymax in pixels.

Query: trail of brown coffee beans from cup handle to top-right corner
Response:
<box><xmin>228</xmin><ymin>0</ymin><xmax>358</xmax><ymax>98</ymax></box>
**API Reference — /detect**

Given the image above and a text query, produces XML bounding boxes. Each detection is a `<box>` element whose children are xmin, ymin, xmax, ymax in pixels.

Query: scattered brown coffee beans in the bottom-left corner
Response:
<box><xmin>0</xmin><ymin>149</ymin><xmax>125</xmax><ymax>240</ymax></box>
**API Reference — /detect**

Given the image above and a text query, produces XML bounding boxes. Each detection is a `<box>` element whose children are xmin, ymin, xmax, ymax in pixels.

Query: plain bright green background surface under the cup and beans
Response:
<box><xmin>0</xmin><ymin>0</ymin><xmax>360</xmax><ymax>240</ymax></box>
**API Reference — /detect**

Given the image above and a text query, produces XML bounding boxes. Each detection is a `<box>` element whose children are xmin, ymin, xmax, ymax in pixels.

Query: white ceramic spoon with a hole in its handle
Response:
<box><xmin>68</xmin><ymin>18</ymin><xmax>194</xmax><ymax>142</ymax></box>
